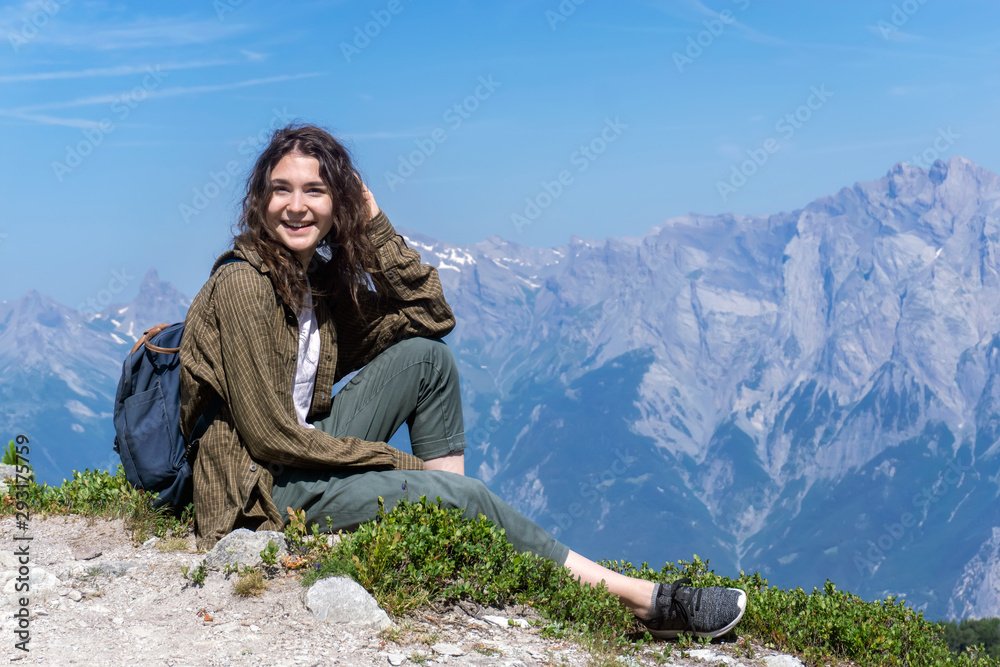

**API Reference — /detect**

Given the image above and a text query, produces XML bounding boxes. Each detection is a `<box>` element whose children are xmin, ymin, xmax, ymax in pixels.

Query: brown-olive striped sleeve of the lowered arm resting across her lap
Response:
<box><xmin>213</xmin><ymin>267</ymin><xmax>423</xmax><ymax>470</ymax></box>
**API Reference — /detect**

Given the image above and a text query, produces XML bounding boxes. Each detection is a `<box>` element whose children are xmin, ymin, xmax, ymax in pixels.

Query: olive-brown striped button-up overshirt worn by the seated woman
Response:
<box><xmin>180</xmin><ymin>212</ymin><xmax>455</xmax><ymax>549</ymax></box>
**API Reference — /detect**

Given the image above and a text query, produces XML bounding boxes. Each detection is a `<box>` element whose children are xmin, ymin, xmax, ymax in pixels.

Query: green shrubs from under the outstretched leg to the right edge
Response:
<box><xmin>298</xmin><ymin>498</ymin><xmax>1000</xmax><ymax>667</ymax></box>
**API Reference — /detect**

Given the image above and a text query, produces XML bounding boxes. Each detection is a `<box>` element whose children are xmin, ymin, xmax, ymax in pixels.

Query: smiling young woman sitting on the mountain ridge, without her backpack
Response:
<box><xmin>180</xmin><ymin>126</ymin><xmax>746</xmax><ymax>637</ymax></box>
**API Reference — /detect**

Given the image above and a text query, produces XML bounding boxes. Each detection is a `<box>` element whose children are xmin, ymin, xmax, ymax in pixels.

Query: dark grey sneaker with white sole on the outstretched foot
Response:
<box><xmin>642</xmin><ymin>579</ymin><xmax>747</xmax><ymax>639</ymax></box>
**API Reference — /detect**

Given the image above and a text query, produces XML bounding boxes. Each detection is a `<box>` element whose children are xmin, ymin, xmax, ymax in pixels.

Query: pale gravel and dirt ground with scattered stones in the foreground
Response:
<box><xmin>0</xmin><ymin>517</ymin><xmax>801</xmax><ymax>667</ymax></box>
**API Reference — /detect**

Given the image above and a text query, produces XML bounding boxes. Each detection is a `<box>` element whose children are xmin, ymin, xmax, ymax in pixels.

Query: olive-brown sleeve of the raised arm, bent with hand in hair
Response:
<box><xmin>332</xmin><ymin>211</ymin><xmax>455</xmax><ymax>379</ymax></box>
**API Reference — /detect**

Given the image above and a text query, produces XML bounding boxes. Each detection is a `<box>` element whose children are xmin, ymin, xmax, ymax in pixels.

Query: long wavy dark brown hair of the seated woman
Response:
<box><xmin>234</xmin><ymin>125</ymin><xmax>375</xmax><ymax>312</ymax></box>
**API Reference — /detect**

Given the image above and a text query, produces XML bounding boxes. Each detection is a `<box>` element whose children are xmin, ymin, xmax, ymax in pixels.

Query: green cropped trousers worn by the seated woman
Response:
<box><xmin>274</xmin><ymin>338</ymin><xmax>569</xmax><ymax>565</ymax></box>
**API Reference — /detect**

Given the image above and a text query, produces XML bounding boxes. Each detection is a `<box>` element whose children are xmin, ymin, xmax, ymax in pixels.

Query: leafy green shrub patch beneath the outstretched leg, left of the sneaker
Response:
<box><xmin>303</xmin><ymin>498</ymin><xmax>635</xmax><ymax>637</ymax></box>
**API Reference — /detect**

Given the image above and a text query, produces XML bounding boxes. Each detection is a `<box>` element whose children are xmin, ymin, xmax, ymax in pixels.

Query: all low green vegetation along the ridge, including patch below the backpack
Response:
<box><xmin>0</xmin><ymin>468</ymin><xmax>1000</xmax><ymax>667</ymax></box>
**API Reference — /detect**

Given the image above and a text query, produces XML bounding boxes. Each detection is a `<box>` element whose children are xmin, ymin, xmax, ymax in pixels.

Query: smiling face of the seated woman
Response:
<box><xmin>266</xmin><ymin>153</ymin><xmax>333</xmax><ymax>268</ymax></box>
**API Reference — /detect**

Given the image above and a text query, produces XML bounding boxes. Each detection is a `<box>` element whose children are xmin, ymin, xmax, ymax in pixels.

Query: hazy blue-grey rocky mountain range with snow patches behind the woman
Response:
<box><xmin>0</xmin><ymin>157</ymin><xmax>1000</xmax><ymax>618</ymax></box>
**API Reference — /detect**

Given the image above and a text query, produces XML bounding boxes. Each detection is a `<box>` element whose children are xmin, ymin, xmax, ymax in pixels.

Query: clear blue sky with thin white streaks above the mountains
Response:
<box><xmin>0</xmin><ymin>0</ymin><xmax>1000</xmax><ymax>306</ymax></box>
